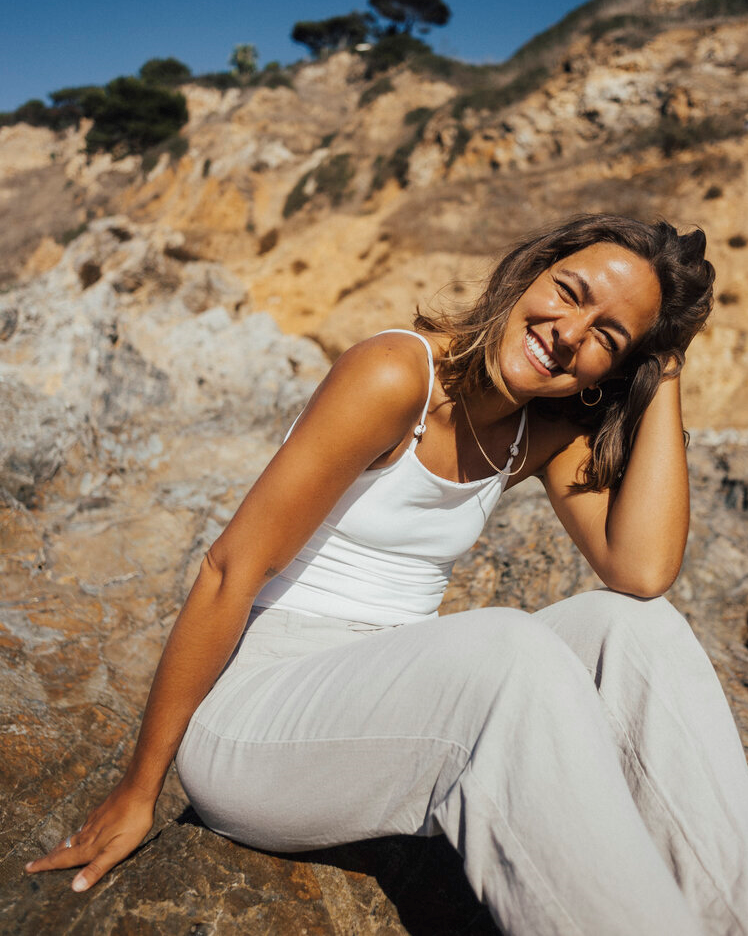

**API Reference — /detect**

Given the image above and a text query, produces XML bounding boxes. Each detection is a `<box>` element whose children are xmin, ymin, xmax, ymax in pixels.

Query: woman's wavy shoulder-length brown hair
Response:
<box><xmin>414</xmin><ymin>214</ymin><xmax>714</xmax><ymax>491</ymax></box>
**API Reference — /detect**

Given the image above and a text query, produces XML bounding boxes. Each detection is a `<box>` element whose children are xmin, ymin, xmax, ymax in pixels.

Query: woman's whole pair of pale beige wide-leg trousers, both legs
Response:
<box><xmin>177</xmin><ymin>590</ymin><xmax>748</xmax><ymax>936</ymax></box>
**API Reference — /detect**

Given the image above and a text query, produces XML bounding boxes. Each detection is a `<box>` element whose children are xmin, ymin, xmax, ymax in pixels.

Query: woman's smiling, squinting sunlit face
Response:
<box><xmin>499</xmin><ymin>243</ymin><xmax>661</xmax><ymax>400</ymax></box>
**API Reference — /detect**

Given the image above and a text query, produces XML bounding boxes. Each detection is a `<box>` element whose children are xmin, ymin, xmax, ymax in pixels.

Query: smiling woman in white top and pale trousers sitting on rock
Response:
<box><xmin>28</xmin><ymin>216</ymin><xmax>748</xmax><ymax>936</ymax></box>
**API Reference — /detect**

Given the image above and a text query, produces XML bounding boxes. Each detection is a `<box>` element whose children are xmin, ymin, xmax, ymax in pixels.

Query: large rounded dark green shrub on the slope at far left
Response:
<box><xmin>83</xmin><ymin>78</ymin><xmax>188</xmax><ymax>156</ymax></box>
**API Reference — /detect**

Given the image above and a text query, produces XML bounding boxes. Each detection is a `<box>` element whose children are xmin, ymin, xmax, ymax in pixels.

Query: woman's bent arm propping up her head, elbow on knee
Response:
<box><xmin>541</xmin><ymin>377</ymin><xmax>689</xmax><ymax>598</ymax></box>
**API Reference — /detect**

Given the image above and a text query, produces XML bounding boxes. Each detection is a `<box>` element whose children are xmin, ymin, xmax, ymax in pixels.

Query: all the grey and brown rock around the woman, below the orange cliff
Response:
<box><xmin>0</xmin><ymin>221</ymin><xmax>748</xmax><ymax>936</ymax></box>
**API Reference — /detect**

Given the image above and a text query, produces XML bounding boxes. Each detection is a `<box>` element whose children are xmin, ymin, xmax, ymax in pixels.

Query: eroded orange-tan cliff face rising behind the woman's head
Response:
<box><xmin>0</xmin><ymin>3</ymin><xmax>748</xmax><ymax>427</ymax></box>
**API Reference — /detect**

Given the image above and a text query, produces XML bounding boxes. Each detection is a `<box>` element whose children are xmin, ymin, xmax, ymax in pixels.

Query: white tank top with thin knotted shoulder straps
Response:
<box><xmin>255</xmin><ymin>328</ymin><xmax>527</xmax><ymax>625</ymax></box>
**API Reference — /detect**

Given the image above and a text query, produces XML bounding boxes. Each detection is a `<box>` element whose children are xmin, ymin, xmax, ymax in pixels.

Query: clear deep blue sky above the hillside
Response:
<box><xmin>0</xmin><ymin>0</ymin><xmax>579</xmax><ymax>111</ymax></box>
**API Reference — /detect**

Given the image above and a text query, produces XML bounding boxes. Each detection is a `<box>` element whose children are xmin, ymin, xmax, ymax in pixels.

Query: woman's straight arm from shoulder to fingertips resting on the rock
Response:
<box><xmin>27</xmin><ymin>335</ymin><xmax>428</xmax><ymax>890</ymax></box>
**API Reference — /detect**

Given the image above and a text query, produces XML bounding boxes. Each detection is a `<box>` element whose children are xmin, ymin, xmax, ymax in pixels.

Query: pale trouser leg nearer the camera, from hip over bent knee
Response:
<box><xmin>177</xmin><ymin>609</ymin><xmax>702</xmax><ymax>936</ymax></box>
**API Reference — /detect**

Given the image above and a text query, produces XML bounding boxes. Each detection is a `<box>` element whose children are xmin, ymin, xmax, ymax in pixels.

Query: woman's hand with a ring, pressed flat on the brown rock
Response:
<box><xmin>26</xmin><ymin>783</ymin><xmax>155</xmax><ymax>891</ymax></box>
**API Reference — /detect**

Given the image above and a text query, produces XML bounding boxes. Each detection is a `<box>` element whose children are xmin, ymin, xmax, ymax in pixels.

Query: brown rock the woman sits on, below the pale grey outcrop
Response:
<box><xmin>0</xmin><ymin>414</ymin><xmax>748</xmax><ymax>936</ymax></box>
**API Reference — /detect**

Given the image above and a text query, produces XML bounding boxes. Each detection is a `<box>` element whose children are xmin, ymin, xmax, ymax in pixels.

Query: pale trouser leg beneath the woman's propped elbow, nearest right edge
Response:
<box><xmin>535</xmin><ymin>590</ymin><xmax>748</xmax><ymax>936</ymax></box>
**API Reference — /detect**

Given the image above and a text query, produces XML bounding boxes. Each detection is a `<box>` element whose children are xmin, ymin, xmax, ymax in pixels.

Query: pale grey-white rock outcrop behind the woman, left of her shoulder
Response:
<box><xmin>0</xmin><ymin>216</ymin><xmax>327</xmax><ymax>442</ymax></box>
